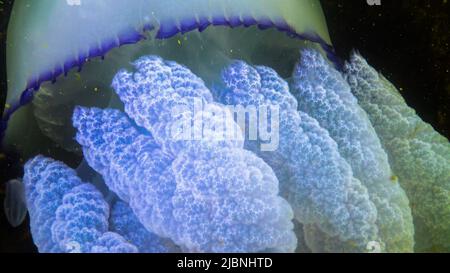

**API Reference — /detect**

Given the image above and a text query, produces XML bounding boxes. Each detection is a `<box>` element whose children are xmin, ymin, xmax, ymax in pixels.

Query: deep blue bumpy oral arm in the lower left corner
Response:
<box><xmin>24</xmin><ymin>156</ymin><xmax>137</xmax><ymax>252</ymax></box>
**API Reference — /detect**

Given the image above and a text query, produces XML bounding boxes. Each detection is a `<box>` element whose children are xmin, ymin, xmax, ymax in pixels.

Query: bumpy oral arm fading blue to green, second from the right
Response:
<box><xmin>292</xmin><ymin>50</ymin><xmax>414</xmax><ymax>252</ymax></box>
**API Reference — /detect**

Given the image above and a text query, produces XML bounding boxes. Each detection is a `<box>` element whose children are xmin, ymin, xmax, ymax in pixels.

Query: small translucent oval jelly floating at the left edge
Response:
<box><xmin>3</xmin><ymin>179</ymin><xmax>28</xmax><ymax>227</ymax></box>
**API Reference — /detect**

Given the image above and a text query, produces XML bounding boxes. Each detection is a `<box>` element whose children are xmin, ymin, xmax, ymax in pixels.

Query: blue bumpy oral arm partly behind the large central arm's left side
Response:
<box><xmin>73</xmin><ymin>107</ymin><xmax>177</xmax><ymax>238</ymax></box>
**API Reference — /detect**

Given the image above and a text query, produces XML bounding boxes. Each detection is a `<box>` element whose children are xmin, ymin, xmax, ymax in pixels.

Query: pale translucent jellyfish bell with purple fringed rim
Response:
<box><xmin>2</xmin><ymin>0</ymin><xmax>332</xmax><ymax>160</ymax></box>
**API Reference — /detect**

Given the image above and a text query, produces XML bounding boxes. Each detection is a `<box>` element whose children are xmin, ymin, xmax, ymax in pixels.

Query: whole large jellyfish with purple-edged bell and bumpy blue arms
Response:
<box><xmin>4</xmin><ymin>0</ymin><xmax>450</xmax><ymax>252</ymax></box>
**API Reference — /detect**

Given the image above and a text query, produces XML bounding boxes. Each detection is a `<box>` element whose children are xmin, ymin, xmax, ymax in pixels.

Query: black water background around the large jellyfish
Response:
<box><xmin>0</xmin><ymin>0</ymin><xmax>450</xmax><ymax>252</ymax></box>
